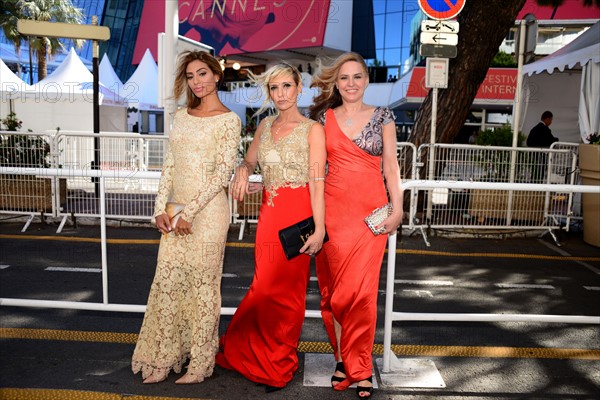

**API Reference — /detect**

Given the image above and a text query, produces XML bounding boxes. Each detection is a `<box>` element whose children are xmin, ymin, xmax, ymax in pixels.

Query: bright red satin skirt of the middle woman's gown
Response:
<box><xmin>216</xmin><ymin>120</ymin><xmax>314</xmax><ymax>387</ymax></box>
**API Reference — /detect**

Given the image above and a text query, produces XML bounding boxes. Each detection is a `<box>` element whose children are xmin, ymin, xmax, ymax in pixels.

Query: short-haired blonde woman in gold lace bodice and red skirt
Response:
<box><xmin>216</xmin><ymin>64</ymin><xmax>326</xmax><ymax>392</ymax></box>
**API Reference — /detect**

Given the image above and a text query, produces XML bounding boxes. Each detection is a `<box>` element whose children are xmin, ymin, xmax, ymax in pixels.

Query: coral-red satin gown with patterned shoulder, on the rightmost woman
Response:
<box><xmin>317</xmin><ymin>108</ymin><xmax>391</xmax><ymax>382</ymax></box>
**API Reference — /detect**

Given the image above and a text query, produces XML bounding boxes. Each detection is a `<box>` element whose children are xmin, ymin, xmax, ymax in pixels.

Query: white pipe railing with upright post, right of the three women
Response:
<box><xmin>382</xmin><ymin>180</ymin><xmax>600</xmax><ymax>373</ymax></box>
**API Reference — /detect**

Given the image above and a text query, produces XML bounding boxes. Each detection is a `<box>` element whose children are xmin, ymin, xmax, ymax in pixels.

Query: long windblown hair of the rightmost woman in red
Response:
<box><xmin>308</xmin><ymin>52</ymin><xmax>369</xmax><ymax>121</ymax></box>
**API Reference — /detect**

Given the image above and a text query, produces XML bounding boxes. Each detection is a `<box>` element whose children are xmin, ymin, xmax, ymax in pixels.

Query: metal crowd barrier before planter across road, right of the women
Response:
<box><xmin>410</xmin><ymin>144</ymin><xmax>577</xmax><ymax>245</ymax></box>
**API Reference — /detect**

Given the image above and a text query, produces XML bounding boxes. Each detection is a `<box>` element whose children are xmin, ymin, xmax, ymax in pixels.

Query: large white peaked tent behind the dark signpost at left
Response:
<box><xmin>14</xmin><ymin>48</ymin><xmax>127</xmax><ymax>132</ymax></box>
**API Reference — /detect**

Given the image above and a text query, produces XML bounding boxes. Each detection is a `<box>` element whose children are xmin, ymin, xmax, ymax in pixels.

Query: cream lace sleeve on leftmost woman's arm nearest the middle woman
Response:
<box><xmin>182</xmin><ymin>116</ymin><xmax>242</xmax><ymax>222</ymax></box>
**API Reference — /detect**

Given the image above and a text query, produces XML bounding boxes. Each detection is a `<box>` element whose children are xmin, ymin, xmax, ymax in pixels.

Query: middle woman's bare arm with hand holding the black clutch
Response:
<box><xmin>300</xmin><ymin>123</ymin><xmax>327</xmax><ymax>255</ymax></box>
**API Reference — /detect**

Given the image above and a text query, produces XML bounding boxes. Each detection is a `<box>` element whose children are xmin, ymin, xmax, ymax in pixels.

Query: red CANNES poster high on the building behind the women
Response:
<box><xmin>133</xmin><ymin>0</ymin><xmax>330</xmax><ymax>64</ymax></box>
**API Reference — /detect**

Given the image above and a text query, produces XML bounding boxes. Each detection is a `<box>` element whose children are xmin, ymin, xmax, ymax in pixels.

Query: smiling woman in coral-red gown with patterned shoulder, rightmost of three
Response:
<box><xmin>310</xmin><ymin>53</ymin><xmax>402</xmax><ymax>398</ymax></box>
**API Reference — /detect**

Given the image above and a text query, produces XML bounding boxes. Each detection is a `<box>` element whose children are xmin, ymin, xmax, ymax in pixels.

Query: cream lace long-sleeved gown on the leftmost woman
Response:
<box><xmin>131</xmin><ymin>109</ymin><xmax>241</xmax><ymax>381</ymax></box>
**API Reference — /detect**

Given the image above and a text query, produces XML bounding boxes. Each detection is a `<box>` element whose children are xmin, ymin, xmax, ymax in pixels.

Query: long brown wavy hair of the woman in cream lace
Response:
<box><xmin>173</xmin><ymin>51</ymin><xmax>223</xmax><ymax>108</ymax></box>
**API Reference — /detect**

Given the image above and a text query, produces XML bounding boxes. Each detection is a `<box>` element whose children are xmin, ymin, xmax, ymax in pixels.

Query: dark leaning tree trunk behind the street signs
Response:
<box><xmin>411</xmin><ymin>0</ymin><xmax>525</xmax><ymax>146</ymax></box>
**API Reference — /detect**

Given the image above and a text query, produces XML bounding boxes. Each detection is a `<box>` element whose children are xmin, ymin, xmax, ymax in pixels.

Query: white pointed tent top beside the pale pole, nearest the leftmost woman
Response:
<box><xmin>123</xmin><ymin>49</ymin><xmax>162</xmax><ymax>111</ymax></box>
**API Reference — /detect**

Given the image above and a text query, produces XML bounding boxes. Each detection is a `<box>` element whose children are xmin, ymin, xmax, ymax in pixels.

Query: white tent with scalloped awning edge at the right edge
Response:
<box><xmin>520</xmin><ymin>22</ymin><xmax>600</xmax><ymax>143</ymax></box>
